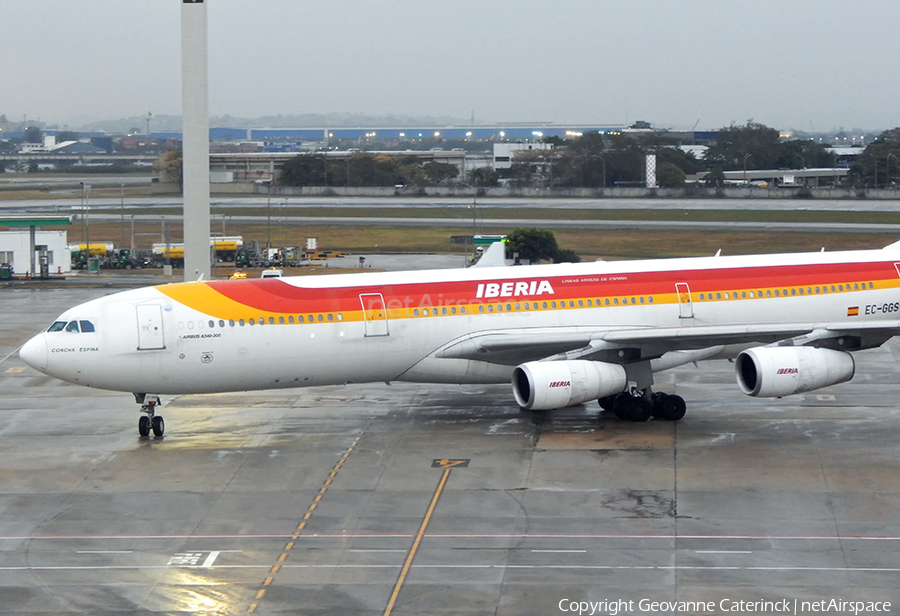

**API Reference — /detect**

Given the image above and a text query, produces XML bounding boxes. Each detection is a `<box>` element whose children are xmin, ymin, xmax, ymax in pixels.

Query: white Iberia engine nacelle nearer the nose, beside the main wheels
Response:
<box><xmin>512</xmin><ymin>360</ymin><xmax>628</xmax><ymax>411</ymax></box>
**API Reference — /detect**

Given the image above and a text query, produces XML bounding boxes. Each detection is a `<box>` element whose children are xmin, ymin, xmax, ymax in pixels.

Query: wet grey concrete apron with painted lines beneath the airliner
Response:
<box><xmin>0</xmin><ymin>288</ymin><xmax>900</xmax><ymax>616</ymax></box>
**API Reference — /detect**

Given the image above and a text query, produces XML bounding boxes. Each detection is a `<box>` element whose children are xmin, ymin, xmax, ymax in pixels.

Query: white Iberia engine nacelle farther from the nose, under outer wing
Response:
<box><xmin>735</xmin><ymin>347</ymin><xmax>856</xmax><ymax>398</ymax></box>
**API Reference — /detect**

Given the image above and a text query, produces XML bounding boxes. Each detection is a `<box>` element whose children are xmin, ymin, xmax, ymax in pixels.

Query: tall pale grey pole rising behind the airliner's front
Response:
<box><xmin>181</xmin><ymin>0</ymin><xmax>210</xmax><ymax>281</ymax></box>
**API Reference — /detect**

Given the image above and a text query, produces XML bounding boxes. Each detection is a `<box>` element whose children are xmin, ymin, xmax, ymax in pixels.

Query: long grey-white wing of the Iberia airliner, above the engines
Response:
<box><xmin>436</xmin><ymin>321</ymin><xmax>900</xmax><ymax>365</ymax></box>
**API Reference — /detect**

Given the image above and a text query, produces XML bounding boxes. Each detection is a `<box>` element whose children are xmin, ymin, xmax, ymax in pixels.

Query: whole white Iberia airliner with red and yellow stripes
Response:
<box><xmin>20</xmin><ymin>242</ymin><xmax>900</xmax><ymax>436</ymax></box>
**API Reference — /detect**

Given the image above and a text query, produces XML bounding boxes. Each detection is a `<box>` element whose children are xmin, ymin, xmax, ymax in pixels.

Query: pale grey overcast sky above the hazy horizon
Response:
<box><xmin>0</xmin><ymin>0</ymin><xmax>900</xmax><ymax>131</ymax></box>
